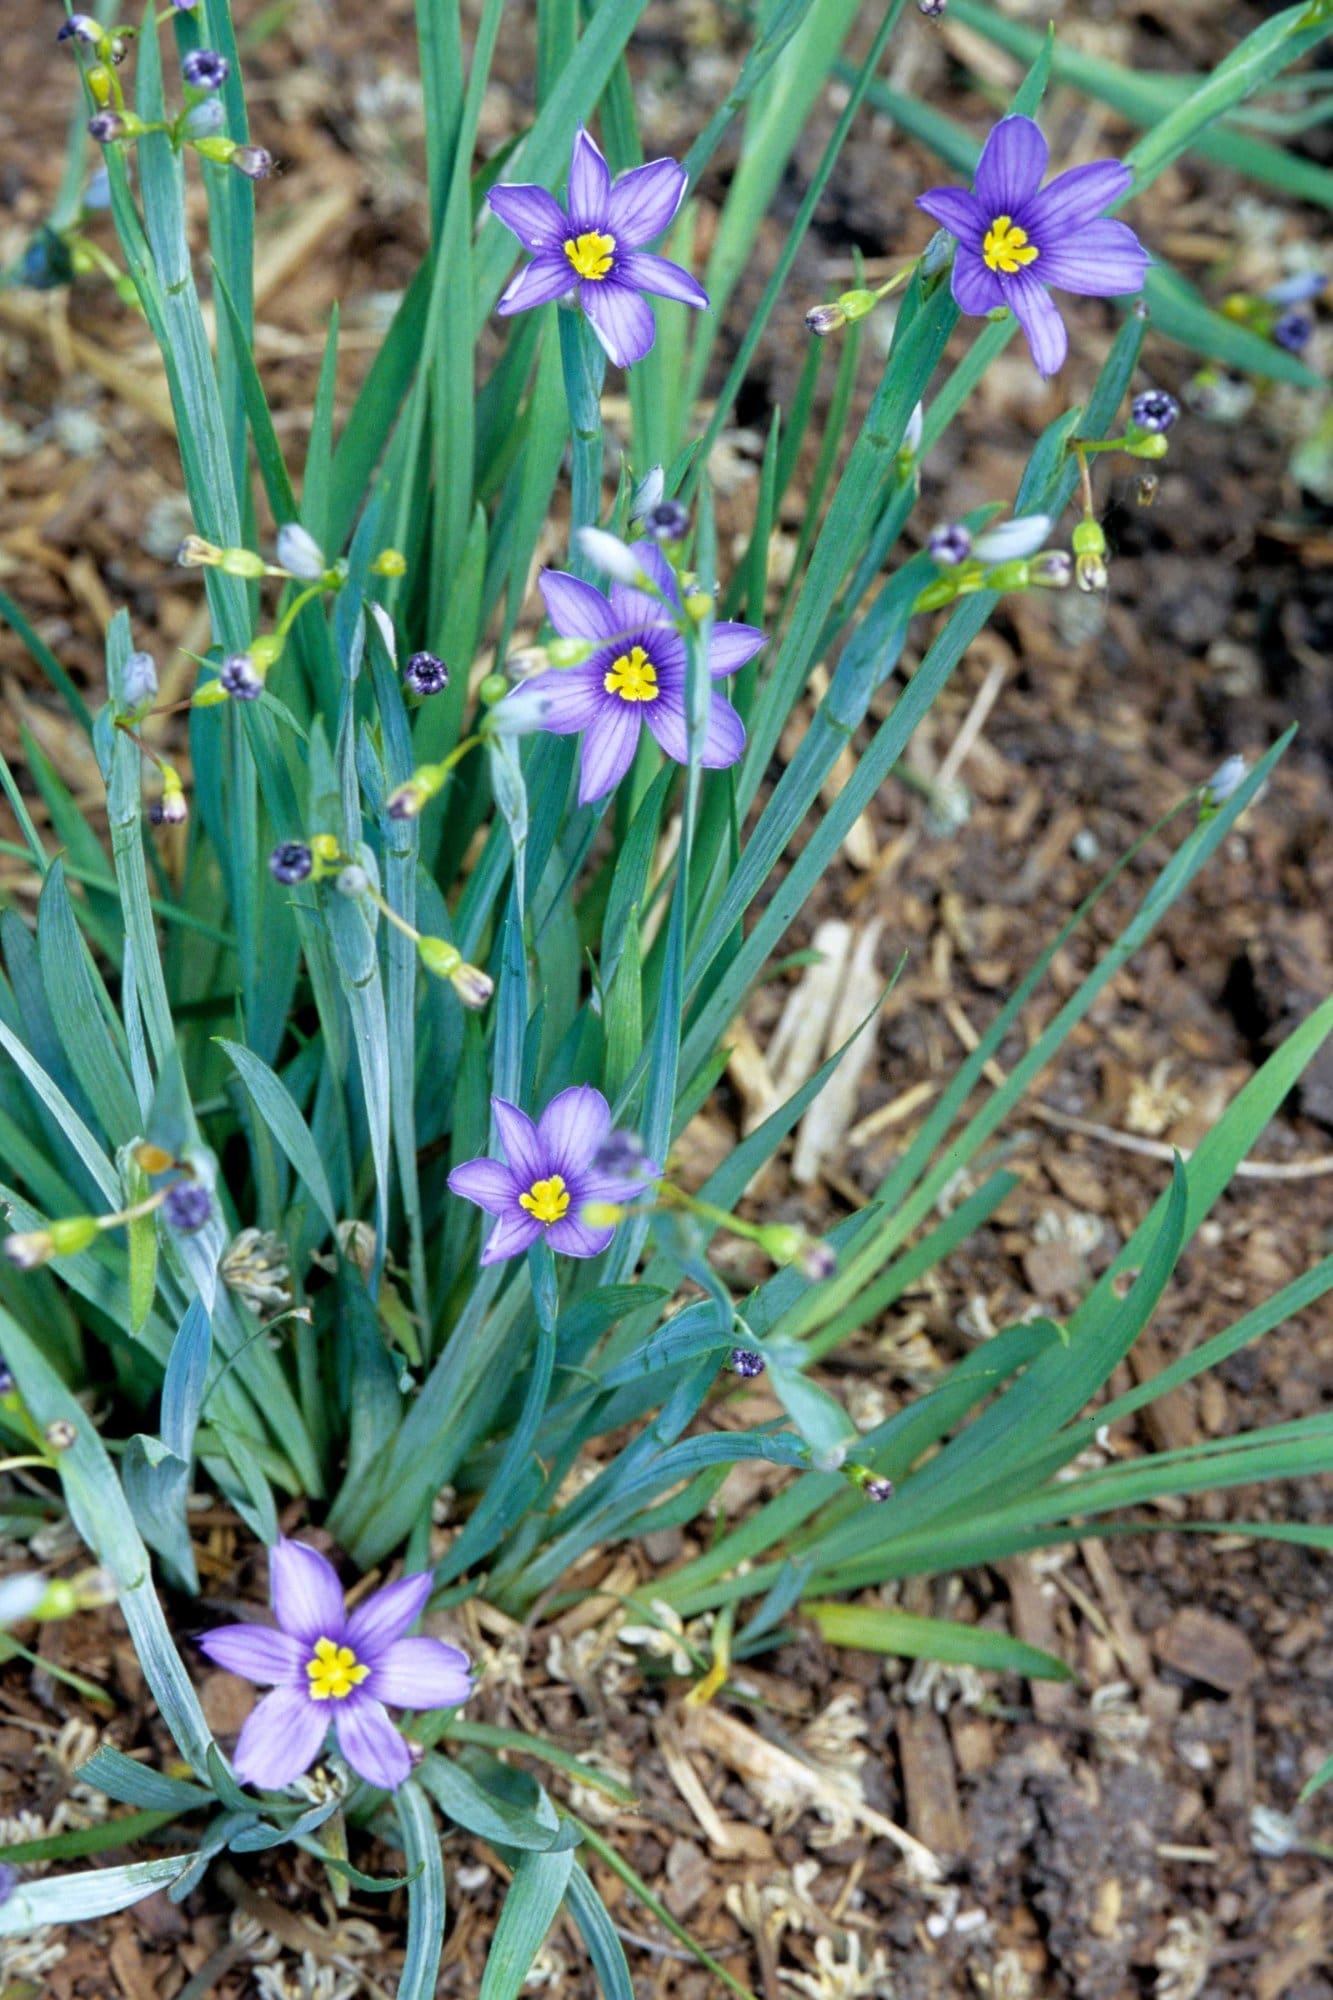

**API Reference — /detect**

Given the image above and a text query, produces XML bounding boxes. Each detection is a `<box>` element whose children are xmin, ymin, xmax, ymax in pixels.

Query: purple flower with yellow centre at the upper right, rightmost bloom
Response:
<box><xmin>917</xmin><ymin>118</ymin><xmax>1151</xmax><ymax>376</ymax></box>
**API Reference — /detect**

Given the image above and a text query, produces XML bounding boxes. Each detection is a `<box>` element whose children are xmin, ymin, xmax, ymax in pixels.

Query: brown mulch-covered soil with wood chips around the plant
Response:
<box><xmin>0</xmin><ymin>0</ymin><xmax>1333</xmax><ymax>2000</ymax></box>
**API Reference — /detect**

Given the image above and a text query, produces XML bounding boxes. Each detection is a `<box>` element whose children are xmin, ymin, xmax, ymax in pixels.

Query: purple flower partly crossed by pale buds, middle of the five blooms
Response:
<box><xmin>500</xmin><ymin>542</ymin><xmax>767</xmax><ymax>806</ymax></box>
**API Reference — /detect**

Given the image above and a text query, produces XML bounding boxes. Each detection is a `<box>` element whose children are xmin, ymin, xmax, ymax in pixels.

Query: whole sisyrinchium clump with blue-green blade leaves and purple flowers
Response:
<box><xmin>0</xmin><ymin>0</ymin><xmax>1333</xmax><ymax>2000</ymax></box>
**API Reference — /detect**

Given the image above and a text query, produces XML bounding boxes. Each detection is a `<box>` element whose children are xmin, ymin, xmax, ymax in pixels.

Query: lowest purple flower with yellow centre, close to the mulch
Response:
<box><xmin>200</xmin><ymin>1540</ymin><xmax>472</xmax><ymax>1792</ymax></box>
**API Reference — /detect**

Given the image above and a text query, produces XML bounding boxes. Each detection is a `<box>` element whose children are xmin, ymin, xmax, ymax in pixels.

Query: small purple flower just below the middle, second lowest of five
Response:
<box><xmin>448</xmin><ymin>1084</ymin><xmax>660</xmax><ymax>1264</ymax></box>
